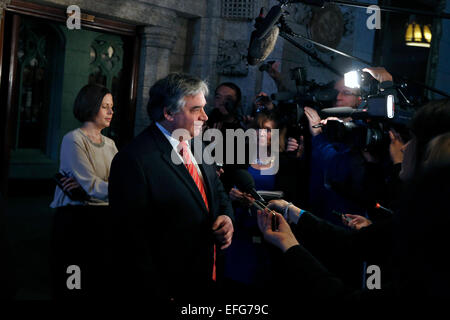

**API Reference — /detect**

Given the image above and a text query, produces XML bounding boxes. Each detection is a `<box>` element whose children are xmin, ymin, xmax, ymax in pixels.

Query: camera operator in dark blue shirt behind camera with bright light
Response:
<box><xmin>304</xmin><ymin>68</ymin><xmax>392</xmax><ymax>225</ymax></box>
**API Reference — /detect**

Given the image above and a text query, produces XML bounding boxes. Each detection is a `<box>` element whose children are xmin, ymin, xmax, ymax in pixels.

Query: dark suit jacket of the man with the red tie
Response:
<box><xmin>109</xmin><ymin>124</ymin><xmax>233</xmax><ymax>300</ymax></box>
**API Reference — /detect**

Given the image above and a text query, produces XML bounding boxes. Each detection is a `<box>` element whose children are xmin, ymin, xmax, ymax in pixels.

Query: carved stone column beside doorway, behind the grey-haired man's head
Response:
<box><xmin>134</xmin><ymin>26</ymin><xmax>177</xmax><ymax>135</ymax></box>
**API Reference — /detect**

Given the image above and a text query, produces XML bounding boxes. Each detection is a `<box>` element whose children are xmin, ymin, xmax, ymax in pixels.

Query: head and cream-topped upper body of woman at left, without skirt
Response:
<box><xmin>50</xmin><ymin>85</ymin><xmax>117</xmax><ymax>208</ymax></box>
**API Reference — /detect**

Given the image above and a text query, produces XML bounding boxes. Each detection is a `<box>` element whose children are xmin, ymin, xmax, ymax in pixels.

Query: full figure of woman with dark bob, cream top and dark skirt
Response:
<box><xmin>50</xmin><ymin>84</ymin><xmax>118</xmax><ymax>297</ymax></box>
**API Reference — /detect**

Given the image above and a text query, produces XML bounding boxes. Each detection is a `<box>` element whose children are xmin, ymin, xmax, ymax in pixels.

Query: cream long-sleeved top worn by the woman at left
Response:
<box><xmin>50</xmin><ymin>128</ymin><xmax>118</xmax><ymax>208</ymax></box>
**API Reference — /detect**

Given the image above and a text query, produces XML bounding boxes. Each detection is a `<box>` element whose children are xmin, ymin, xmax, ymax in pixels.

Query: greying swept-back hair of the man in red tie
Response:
<box><xmin>147</xmin><ymin>73</ymin><xmax>208</xmax><ymax>121</ymax></box>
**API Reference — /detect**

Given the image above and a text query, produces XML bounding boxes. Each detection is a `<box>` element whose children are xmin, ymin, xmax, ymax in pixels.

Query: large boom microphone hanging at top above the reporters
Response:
<box><xmin>247</xmin><ymin>5</ymin><xmax>283</xmax><ymax>66</ymax></box>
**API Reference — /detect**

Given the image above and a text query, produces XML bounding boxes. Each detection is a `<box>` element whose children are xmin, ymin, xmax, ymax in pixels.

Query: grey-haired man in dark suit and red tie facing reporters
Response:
<box><xmin>109</xmin><ymin>73</ymin><xmax>233</xmax><ymax>301</ymax></box>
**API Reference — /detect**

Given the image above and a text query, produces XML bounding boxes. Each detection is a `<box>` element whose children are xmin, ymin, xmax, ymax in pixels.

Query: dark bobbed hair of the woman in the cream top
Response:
<box><xmin>73</xmin><ymin>84</ymin><xmax>111</xmax><ymax>122</ymax></box>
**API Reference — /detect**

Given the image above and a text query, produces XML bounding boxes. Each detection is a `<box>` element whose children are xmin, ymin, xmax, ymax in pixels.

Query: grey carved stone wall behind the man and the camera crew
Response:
<box><xmin>4</xmin><ymin>0</ymin><xmax>450</xmax><ymax>134</ymax></box>
